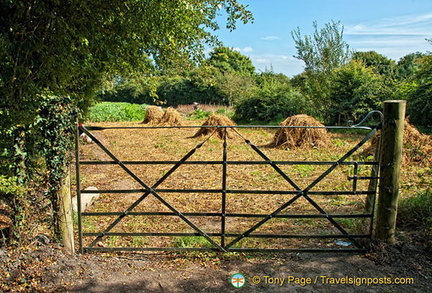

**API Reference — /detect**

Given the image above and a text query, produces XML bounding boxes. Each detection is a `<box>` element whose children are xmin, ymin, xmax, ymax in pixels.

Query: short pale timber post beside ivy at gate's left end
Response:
<box><xmin>59</xmin><ymin>168</ymin><xmax>75</xmax><ymax>253</ymax></box>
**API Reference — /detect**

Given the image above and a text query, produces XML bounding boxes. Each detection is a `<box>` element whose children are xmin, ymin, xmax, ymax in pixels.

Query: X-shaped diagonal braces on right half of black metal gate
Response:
<box><xmin>225</xmin><ymin>128</ymin><xmax>378</xmax><ymax>250</ymax></box>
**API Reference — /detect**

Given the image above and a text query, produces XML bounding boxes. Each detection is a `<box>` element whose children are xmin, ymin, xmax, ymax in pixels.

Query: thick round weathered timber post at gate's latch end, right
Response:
<box><xmin>374</xmin><ymin>100</ymin><xmax>406</xmax><ymax>244</ymax></box>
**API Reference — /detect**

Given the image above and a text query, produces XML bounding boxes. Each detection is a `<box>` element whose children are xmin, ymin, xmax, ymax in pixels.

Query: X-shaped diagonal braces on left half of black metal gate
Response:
<box><xmin>79</xmin><ymin>126</ymin><xmax>226</xmax><ymax>252</ymax></box>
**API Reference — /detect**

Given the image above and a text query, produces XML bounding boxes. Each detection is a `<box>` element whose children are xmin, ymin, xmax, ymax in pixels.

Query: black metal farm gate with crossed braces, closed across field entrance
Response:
<box><xmin>76</xmin><ymin>111</ymin><xmax>382</xmax><ymax>252</ymax></box>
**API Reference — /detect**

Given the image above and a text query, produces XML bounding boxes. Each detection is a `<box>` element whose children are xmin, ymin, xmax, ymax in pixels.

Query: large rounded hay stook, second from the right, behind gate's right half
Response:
<box><xmin>270</xmin><ymin>114</ymin><xmax>331</xmax><ymax>149</ymax></box>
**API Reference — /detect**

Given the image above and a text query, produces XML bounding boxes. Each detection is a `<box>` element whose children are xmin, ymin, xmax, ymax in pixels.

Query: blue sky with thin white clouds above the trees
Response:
<box><xmin>216</xmin><ymin>0</ymin><xmax>432</xmax><ymax>77</ymax></box>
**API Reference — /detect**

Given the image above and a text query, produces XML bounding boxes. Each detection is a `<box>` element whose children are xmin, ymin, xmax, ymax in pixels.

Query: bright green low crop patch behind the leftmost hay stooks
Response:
<box><xmin>89</xmin><ymin>102</ymin><xmax>146</xmax><ymax>122</ymax></box>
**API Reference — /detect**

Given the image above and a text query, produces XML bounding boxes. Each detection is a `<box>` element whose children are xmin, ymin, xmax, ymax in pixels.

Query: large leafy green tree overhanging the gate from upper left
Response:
<box><xmin>0</xmin><ymin>0</ymin><xmax>251</xmax><ymax>242</ymax></box>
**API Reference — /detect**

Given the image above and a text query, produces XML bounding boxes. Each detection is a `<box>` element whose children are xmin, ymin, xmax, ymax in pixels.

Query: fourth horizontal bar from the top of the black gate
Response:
<box><xmin>81</xmin><ymin>212</ymin><xmax>373</xmax><ymax>219</ymax></box>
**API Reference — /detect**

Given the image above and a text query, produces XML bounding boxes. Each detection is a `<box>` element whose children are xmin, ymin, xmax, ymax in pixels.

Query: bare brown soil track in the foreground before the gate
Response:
<box><xmin>0</xmin><ymin>235</ymin><xmax>432</xmax><ymax>292</ymax></box>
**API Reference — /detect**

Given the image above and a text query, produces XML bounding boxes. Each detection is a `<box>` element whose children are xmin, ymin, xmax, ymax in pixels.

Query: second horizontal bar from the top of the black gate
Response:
<box><xmin>79</xmin><ymin>161</ymin><xmax>378</xmax><ymax>166</ymax></box>
